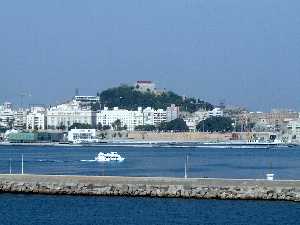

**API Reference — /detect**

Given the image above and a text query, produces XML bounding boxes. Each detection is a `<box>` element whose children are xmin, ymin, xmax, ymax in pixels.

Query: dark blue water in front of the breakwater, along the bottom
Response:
<box><xmin>0</xmin><ymin>194</ymin><xmax>300</xmax><ymax>225</ymax></box>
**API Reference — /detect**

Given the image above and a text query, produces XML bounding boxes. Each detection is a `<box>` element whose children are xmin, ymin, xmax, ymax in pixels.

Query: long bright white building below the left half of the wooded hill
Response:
<box><xmin>97</xmin><ymin>107</ymin><xmax>143</xmax><ymax>131</ymax></box>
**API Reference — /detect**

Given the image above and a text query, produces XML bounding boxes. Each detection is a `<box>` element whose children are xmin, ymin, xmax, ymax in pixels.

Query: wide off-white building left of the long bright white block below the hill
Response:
<box><xmin>47</xmin><ymin>100</ymin><xmax>96</xmax><ymax>129</ymax></box>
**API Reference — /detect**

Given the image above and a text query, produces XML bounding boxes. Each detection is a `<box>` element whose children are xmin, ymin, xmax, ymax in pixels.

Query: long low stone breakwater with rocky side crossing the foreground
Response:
<box><xmin>0</xmin><ymin>175</ymin><xmax>300</xmax><ymax>201</ymax></box>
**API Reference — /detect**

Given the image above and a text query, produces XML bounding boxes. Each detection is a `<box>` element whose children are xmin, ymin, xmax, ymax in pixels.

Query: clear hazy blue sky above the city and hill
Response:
<box><xmin>0</xmin><ymin>0</ymin><xmax>300</xmax><ymax>111</ymax></box>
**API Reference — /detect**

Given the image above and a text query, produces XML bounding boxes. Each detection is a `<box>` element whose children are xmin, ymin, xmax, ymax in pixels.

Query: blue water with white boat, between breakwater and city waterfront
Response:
<box><xmin>0</xmin><ymin>146</ymin><xmax>300</xmax><ymax>179</ymax></box>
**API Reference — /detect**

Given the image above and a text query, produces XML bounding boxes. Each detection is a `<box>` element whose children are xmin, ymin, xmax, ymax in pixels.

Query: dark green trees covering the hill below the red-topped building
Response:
<box><xmin>98</xmin><ymin>85</ymin><xmax>213</xmax><ymax>112</ymax></box>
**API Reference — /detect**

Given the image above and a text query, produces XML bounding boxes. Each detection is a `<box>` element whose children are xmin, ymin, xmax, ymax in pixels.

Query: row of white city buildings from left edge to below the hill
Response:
<box><xmin>0</xmin><ymin>96</ymin><xmax>179</xmax><ymax>130</ymax></box>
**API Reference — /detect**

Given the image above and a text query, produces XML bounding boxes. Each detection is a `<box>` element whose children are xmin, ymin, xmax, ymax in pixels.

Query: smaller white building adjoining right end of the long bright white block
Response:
<box><xmin>143</xmin><ymin>107</ymin><xmax>167</xmax><ymax>126</ymax></box>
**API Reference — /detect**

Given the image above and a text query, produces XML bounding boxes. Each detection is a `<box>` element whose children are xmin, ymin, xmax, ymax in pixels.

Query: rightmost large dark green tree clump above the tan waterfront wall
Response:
<box><xmin>197</xmin><ymin>117</ymin><xmax>233</xmax><ymax>132</ymax></box>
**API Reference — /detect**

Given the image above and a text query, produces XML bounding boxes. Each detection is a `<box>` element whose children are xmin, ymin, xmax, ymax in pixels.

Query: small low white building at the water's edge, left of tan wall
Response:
<box><xmin>68</xmin><ymin>129</ymin><xmax>96</xmax><ymax>143</ymax></box>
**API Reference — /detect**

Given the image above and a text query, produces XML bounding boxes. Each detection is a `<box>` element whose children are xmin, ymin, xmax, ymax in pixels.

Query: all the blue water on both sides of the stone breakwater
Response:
<box><xmin>0</xmin><ymin>146</ymin><xmax>300</xmax><ymax>225</ymax></box>
